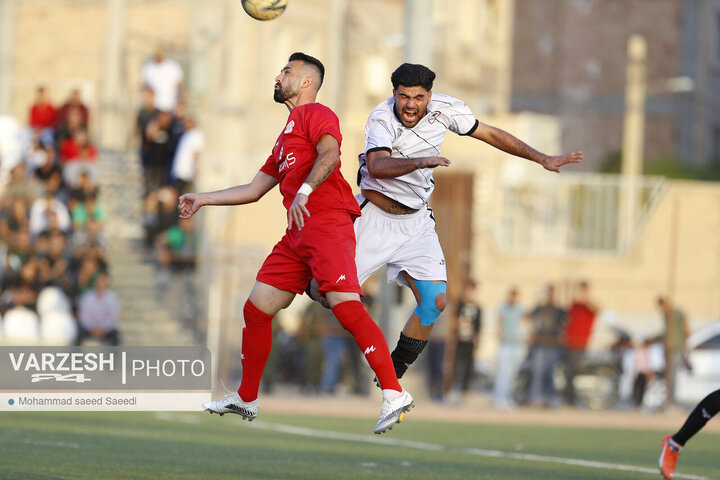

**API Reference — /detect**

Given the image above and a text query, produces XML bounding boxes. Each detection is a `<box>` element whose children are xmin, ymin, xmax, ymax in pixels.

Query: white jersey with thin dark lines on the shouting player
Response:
<box><xmin>358</xmin><ymin>93</ymin><xmax>479</xmax><ymax>209</ymax></box>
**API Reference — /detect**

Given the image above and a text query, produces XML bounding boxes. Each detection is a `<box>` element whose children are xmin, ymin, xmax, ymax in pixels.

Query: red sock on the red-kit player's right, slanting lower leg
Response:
<box><xmin>334</xmin><ymin>300</ymin><xmax>402</xmax><ymax>392</ymax></box>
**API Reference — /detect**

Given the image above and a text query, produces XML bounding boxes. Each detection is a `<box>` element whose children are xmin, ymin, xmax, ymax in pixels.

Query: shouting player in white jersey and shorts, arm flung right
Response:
<box><xmin>308</xmin><ymin>63</ymin><xmax>582</xmax><ymax>378</ymax></box>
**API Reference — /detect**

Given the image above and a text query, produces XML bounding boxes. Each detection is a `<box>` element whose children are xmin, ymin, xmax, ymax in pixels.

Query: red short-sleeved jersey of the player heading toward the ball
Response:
<box><xmin>260</xmin><ymin>103</ymin><xmax>360</xmax><ymax>218</ymax></box>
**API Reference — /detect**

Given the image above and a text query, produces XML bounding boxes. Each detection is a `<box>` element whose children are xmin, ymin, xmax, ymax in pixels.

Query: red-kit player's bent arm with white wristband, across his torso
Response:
<box><xmin>288</xmin><ymin>133</ymin><xmax>340</xmax><ymax>230</ymax></box>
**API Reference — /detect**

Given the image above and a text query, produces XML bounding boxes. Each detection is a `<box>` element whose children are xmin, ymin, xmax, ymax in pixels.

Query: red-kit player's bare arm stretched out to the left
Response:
<box><xmin>178</xmin><ymin>172</ymin><xmax>278</xmax><ymax>218</ymax></box>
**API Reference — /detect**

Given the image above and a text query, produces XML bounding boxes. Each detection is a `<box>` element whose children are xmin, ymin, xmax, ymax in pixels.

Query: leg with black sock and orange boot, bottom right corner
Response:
<box><xmin>658</xmin><ymin>390</ymin><xmax>720</xmax><ymax>480</ymax></box>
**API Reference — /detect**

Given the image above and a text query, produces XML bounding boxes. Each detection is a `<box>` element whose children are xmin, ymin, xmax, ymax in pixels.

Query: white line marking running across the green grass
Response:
<box><xmin>158</xmin><ymin>413</ymin><xmax>710</xmax><ymax>480</ymax></box>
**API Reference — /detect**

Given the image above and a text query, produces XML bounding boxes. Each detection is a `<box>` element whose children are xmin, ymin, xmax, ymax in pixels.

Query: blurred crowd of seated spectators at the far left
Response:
<box><xmin>0</xmin><ymin>87</ymin><xmax>119</xmax><ymax>345</ymax></box>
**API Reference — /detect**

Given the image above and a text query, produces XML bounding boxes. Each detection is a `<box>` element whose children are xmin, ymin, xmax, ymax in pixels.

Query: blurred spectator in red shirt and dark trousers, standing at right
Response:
<box><xmin>565</xmin><ymin>282</ymin><xmax>598</xmax><ymax>406</ymax></box>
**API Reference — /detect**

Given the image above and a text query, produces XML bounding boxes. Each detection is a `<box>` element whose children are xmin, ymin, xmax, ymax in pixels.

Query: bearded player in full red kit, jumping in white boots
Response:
<box><xmin>179</xmin><ymin>53</ymin><xmax>413</xmax><ymax>433</ymax></box>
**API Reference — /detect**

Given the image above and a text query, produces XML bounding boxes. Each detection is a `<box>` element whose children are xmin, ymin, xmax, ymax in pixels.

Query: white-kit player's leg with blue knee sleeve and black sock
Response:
<box><xmin>391</xmin><ymin>271</ymin><xmax>446</xmax><ymax>378</ymax></box>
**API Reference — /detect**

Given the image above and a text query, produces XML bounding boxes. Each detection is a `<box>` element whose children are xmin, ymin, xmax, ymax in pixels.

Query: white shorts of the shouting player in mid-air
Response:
<box><xmin>354</xmin><ymin>194</ymin><xmax>447</xmax><ymax>286</ymax></box>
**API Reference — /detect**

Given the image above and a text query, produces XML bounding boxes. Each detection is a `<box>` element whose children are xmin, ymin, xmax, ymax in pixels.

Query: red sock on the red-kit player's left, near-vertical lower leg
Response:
<box><xmin>238</xmin><ymin>300</ymin><xmax>273</xmax><ymax>402</ymax></box>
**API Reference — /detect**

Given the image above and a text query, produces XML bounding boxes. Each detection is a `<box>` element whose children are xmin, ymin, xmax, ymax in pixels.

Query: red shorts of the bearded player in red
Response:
<box><xmin>257</xmin><ymin>210</ymin><xmax>362</xmax><ymax>295</ymax></box>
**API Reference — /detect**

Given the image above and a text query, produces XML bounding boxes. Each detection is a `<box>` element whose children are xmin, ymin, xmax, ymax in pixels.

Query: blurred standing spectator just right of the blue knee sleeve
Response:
<box><xmin>455</xmin><ymin>280</ymin><xmax>482</xmax><ymax>393</ymax></box>
